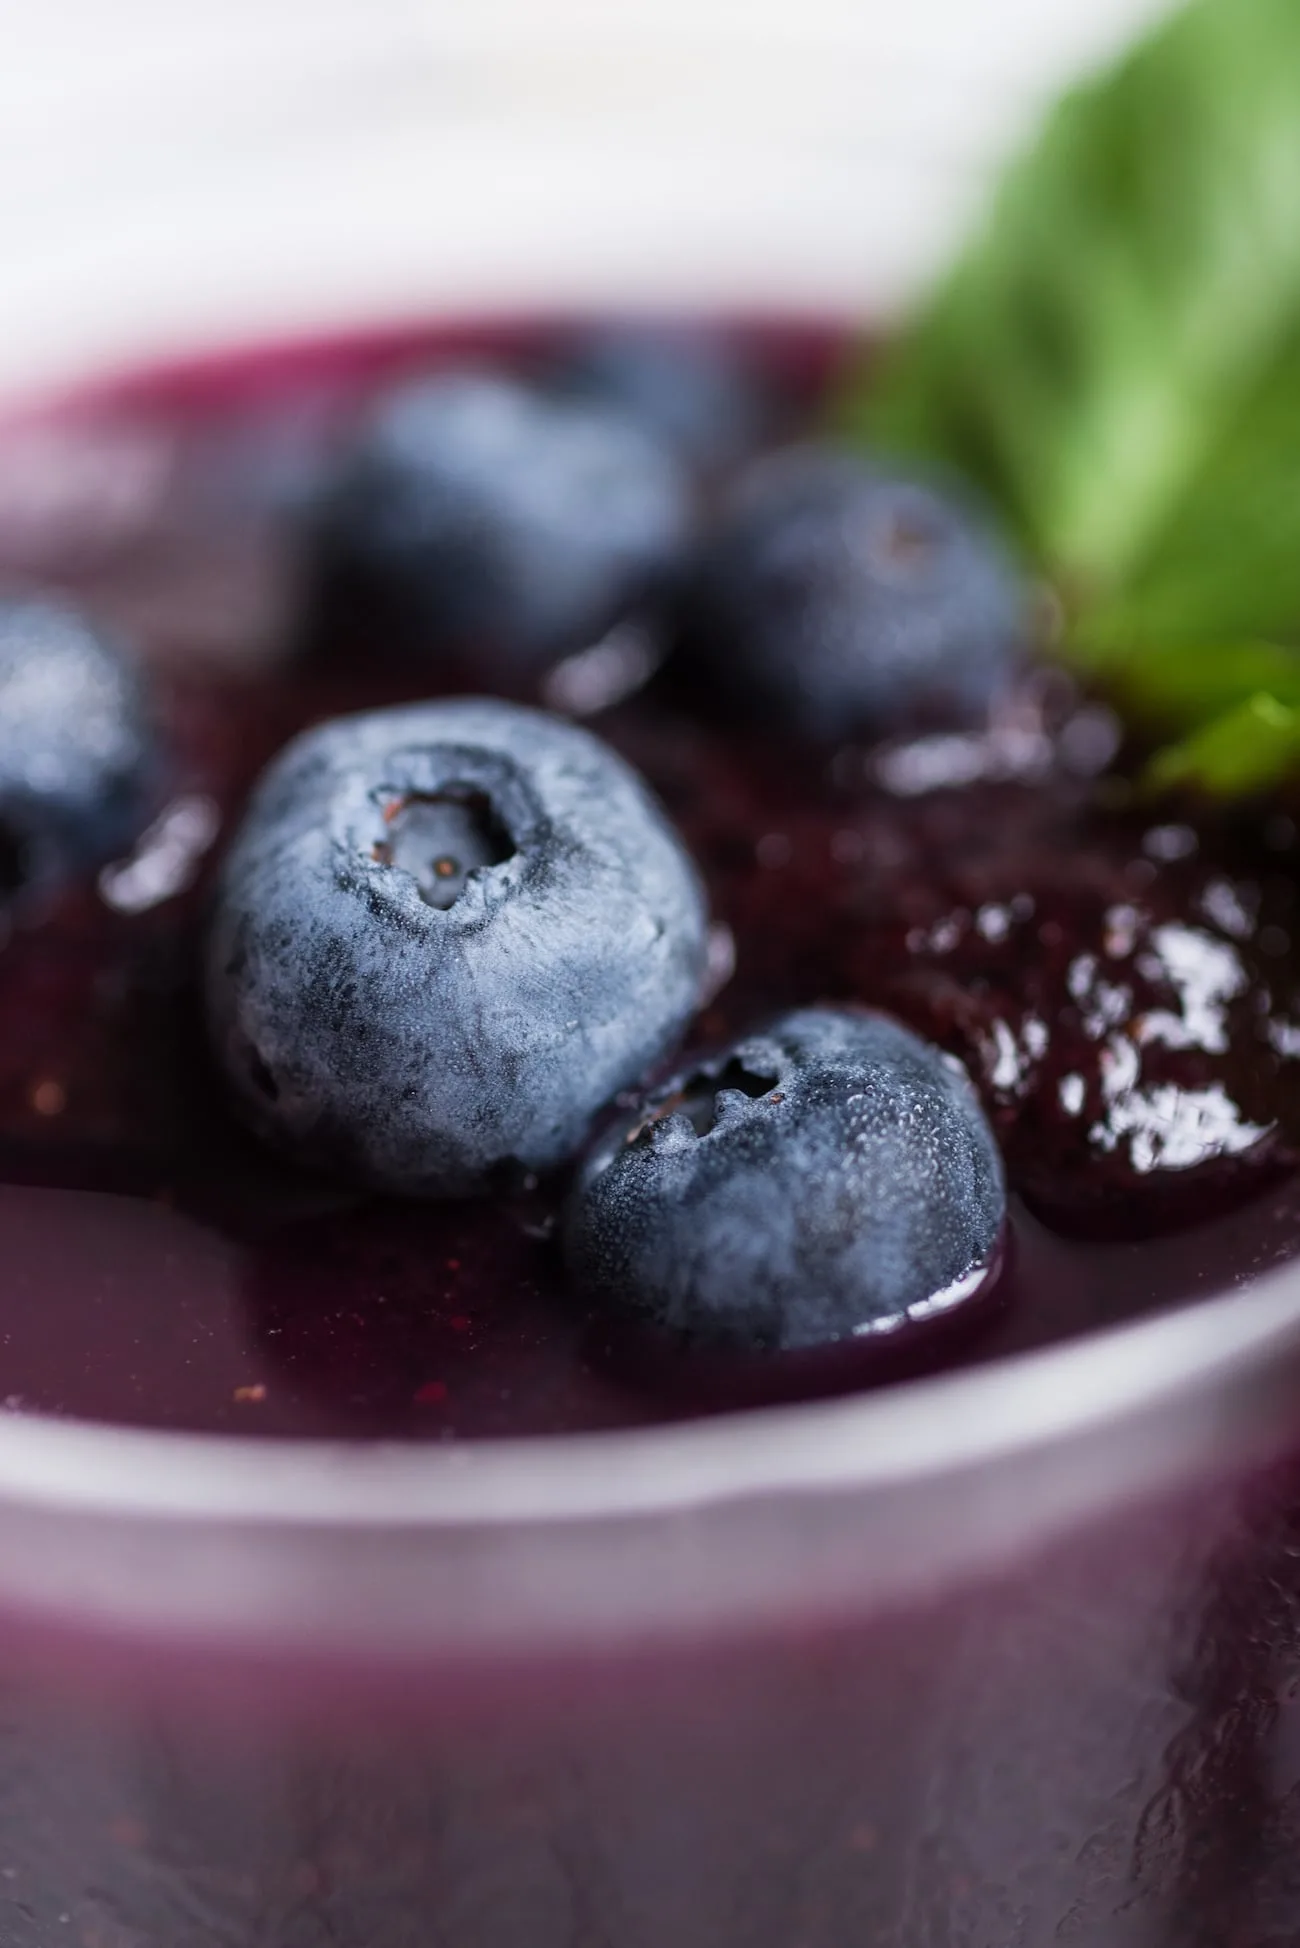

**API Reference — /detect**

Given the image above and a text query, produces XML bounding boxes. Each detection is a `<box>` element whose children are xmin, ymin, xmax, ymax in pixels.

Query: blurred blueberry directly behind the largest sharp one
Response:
<box><xmin>316</xmin><ymin>370</ymin><xmax>690</xmax><ymax>678</ymax></box>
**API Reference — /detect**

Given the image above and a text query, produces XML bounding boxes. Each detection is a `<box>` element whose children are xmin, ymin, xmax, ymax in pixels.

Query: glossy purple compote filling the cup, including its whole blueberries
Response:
<box><xmin>0</xmin><ymin>325</ymin><xmax>1300</xmax><ymax>1440</ymax></box>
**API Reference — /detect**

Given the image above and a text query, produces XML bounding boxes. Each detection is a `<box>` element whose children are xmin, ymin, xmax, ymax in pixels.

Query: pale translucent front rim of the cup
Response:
<box><xmin>0</xmin><ymin>1260</ymin><xmax>1300</xmax><ymax>1531</ymax></box>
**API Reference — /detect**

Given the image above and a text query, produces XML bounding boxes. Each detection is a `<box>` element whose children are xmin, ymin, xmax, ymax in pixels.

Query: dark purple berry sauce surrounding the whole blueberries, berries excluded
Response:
<box><xmin>0</xmin><ymin>315</ymin><xmax>1300</xmax><ymax>1440</ymax></box>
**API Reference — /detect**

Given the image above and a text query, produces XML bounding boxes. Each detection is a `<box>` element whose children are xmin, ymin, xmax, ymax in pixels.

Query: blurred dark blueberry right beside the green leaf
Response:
<box><xmin>684</xmin><ymin>446</ymin><xmax>1025</xmax><ymax>738</ymax></box>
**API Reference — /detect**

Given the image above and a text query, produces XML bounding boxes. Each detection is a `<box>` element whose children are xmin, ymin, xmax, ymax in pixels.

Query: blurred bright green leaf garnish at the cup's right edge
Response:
<box><xmin>844</xmin><ymin>0</ymin><xmax>1300</xmax><ymax>789</ymax></box>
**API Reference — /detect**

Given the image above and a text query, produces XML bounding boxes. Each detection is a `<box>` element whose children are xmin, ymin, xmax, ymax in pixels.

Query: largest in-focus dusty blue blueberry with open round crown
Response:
<box><xmin>207</xmin><ymin>699</ymin><xmax>706</xmax><ymax>1196</ymax></box>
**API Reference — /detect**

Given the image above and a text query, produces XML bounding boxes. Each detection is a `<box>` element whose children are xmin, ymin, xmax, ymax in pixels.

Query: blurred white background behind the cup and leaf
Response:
<box><xmin>0</xmin><ymin>0</ymin><xmax>1167</xmax><ymax>390</ymax></box>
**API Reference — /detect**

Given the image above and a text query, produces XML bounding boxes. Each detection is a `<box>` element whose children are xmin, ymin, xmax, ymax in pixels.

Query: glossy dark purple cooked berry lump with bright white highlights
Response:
<box><xmin>884</xmin><ymin>868</ymin><xmax>1300</xmax><ymax>1237</ymax></box>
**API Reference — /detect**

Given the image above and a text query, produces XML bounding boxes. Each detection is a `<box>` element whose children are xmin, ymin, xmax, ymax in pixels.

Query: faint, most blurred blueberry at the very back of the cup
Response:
<box><xmin>557</xmin><ymin>325</ymin><xmax>770</xmax><ymax>473</ymax></box>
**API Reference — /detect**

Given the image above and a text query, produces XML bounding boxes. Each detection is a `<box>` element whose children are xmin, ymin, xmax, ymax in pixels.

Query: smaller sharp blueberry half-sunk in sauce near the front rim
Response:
<box><xmin>565</xmin><ymin>1009</ymin><xmax>1006</xmax><ymax>1352</ymax></box>
